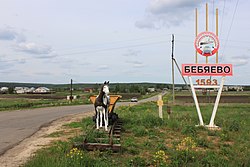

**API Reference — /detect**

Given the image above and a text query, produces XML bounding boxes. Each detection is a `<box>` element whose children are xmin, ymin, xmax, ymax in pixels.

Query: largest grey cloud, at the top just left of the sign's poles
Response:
<box><xmin>135</xmin><ymin>0</ymin><xmax>203</xmax><ymax>29</ymax></box>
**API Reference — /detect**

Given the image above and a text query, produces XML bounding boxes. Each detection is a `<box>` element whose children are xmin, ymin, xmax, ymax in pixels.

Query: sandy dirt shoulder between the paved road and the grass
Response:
<box><xmin>0</xmin><ymin>112</ymin><xmax>93</xmax><ymax>167</ymax></box>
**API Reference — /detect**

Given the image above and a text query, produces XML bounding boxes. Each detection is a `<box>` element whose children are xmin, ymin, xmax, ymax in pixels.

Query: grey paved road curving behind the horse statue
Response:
<box><xmin>0</xmin><ymin>96</ymin><xmax>160</xmax><ymax>155</ymax></box>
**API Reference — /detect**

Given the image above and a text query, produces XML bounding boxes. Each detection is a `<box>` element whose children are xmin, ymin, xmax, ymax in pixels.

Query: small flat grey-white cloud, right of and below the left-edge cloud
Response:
<box><xmin>16</xmin><ymin>42</ymin><xmax>52</xmax><ymax>55</ymax></box>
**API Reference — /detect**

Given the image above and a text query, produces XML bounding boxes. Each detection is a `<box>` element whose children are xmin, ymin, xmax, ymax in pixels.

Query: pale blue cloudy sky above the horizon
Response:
<box><xmin>0</xmin><ymin>0</ymin><xmax>250</xmax><ymax>85</ymax></box>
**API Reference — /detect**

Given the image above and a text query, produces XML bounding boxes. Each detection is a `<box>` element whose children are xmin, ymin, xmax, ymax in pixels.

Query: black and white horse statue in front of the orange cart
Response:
<box><xmin>94</xmin><ymin>81</ymin><xmax>110</xmax><ymax>131</ymax></box>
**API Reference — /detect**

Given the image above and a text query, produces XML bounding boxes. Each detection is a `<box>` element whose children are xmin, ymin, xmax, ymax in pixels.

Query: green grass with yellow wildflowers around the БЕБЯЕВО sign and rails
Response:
<box><xmin>24</xmin><ymin>102</ymin><xmax>250</xmax><ymax>167</ymax></box>
